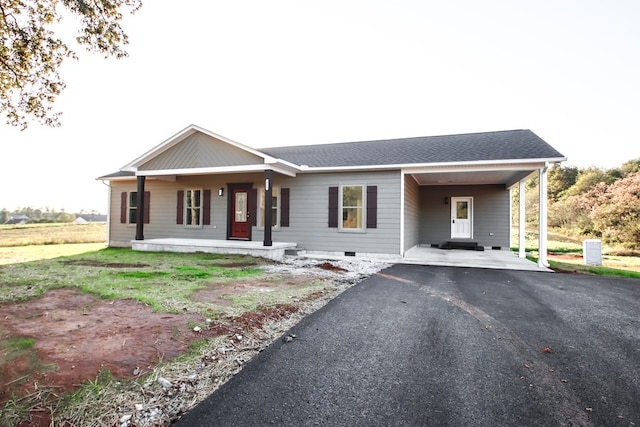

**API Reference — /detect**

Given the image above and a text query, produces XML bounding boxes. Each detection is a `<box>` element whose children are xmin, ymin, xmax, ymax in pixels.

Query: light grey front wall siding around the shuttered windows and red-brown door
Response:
<box><xmin>109</xmin><ymin>171</ymin><xmax>400</xmax><ymax>255</ymax></box>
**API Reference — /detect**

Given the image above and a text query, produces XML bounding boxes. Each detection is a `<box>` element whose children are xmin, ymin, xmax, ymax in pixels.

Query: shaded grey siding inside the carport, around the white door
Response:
<box><xmin>420</xmin><ymin>185</ymin><xmax>510</xmax><ymax>248</ymax></box>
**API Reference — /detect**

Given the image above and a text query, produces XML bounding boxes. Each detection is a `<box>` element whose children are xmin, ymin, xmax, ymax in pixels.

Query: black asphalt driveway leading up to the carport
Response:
<box><xmin>175</xmin><ymin>265</ymin><xmax>640</xmax><ymax>426</ymax></box>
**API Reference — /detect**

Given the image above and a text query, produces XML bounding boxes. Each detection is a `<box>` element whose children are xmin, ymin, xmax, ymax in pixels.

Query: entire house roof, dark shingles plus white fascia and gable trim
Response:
<box><xmin>98</xmin><ymin>125</ymin><xmax>566</xmax><ymax>184</ymax></box>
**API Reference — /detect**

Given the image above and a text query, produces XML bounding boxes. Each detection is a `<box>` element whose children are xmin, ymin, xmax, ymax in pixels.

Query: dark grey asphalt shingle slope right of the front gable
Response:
<box><xmin>260</xmin><ymin>129</ymin><xmax>564</xmax><ymax>167</ymax></box>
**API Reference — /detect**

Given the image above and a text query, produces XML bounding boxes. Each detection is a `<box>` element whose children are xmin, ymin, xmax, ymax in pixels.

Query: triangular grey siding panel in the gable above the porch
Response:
<box><xmin>139</xmin><ymin>133</ymin><xmax>264</xmax><ymax>170</ymax></box>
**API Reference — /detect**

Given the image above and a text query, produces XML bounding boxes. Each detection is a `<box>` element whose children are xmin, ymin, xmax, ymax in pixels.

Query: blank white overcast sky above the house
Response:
<box><xmin>0</xmin><ymin>0</ymin><xmax>640</xmax><ymax>213</ymax></box>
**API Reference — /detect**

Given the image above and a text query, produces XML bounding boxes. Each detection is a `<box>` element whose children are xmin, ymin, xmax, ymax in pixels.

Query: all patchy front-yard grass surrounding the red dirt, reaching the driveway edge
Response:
<box><xmin>0</xmin><ymin>248</ymin><xmax>337</xmax><ymax>427</ymax></box>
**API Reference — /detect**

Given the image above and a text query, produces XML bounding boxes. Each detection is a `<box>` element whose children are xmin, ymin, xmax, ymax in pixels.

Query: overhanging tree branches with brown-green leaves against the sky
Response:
<box><xmin>0</xmin><ymin>0</ymin><xmax>142</xmax><ymax>129</ymax></box>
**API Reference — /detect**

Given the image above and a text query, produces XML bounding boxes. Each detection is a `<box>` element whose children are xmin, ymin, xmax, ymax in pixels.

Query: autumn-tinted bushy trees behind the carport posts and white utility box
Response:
<box><xmin>513</xmin><ymin>159</ymin><xmax>640</xmax><ymax>250</ymax></box>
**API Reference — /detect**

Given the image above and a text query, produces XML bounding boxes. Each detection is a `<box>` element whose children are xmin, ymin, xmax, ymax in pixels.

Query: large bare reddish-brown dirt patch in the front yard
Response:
<box><xmin>0</xmin><ymin>289</ymin><xmax>204</xmax><ymax>403</ymax></box>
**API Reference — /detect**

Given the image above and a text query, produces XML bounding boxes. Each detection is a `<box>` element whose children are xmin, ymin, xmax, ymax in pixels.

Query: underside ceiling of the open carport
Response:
<box><xmin>411</xmin><ymin>169</ymin><xmax>537</xmax><ymax>187</ymax></box>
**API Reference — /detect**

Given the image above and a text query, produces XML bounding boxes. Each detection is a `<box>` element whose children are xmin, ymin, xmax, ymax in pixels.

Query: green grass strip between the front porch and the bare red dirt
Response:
<box><xmin>0</xmin><ymin>248</ymin><xmax>284</xmax><ymax>313</ymax></box>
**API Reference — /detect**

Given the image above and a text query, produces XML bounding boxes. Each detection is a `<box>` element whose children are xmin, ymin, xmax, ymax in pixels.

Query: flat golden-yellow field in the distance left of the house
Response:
<box><xmin>0</xmin><ymin>222</ymin><xmax>107</xmax><ymax>247</ymax></box>
